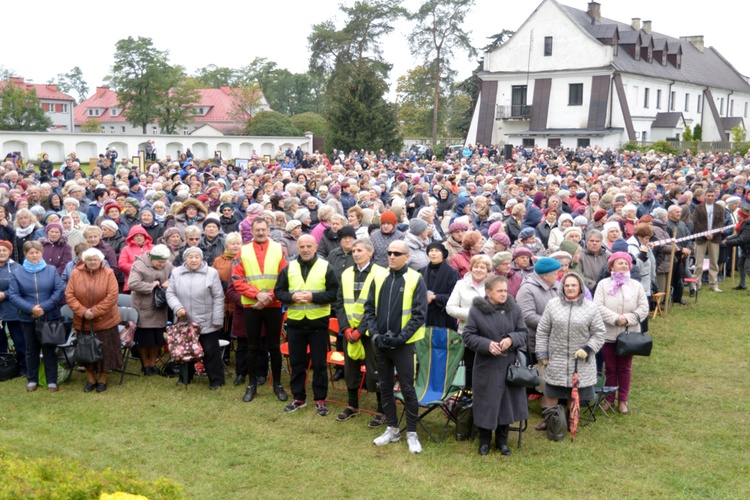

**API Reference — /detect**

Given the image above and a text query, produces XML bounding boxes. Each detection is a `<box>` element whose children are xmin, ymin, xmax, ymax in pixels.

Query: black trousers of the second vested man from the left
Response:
<box><xmin>288</xmin><ymin>327</ymin><xmax>329</xmax><ymax>401</ymax></box>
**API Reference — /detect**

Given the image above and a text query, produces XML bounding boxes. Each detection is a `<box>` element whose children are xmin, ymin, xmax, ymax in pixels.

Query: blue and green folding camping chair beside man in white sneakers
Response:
<box><xmin>395</xmin><ymin>327</ymin><xmax>464</xmax><ymax>443</ymax></box>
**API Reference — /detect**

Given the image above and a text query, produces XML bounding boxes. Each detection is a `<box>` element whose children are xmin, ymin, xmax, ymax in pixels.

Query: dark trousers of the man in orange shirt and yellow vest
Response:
<box><xmin>243</xmin><ymin>307</ymin><xmax>284</xmax><ymax>385</ymax></box>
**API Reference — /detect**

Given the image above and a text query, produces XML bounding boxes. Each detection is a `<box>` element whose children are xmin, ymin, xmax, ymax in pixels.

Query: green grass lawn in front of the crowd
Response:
<box><xmin>0</xmin><ymin>288</ymin><xmax>750</xmax><ymax>499</ymax></box>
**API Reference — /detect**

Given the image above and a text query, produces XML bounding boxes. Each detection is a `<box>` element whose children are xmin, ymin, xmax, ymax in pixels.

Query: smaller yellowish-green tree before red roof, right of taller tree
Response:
<box><xmin>152</xmin><ymin>66</ymin><xmax>200</xmax><ymax>134</ymax></box>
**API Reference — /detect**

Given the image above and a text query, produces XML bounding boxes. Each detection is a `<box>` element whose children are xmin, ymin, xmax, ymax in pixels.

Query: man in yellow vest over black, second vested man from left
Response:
<box><xmin>274</xmin><ymin>234</ymin><xmax>339</xmax><ymax>417</ymax></box>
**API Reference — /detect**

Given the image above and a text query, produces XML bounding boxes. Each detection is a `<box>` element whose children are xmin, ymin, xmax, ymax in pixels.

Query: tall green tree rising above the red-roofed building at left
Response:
<box><xmin>107</xmin><ymin>37</ymin><xmax>169</xmax><ymax>134</ymax></box>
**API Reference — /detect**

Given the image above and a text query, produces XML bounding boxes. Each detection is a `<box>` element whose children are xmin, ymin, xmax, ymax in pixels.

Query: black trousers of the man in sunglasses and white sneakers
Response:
<box><xmin>375</xmin><ymin>344</ymin><xmax>420</xmax><ymax>432</ymax></box>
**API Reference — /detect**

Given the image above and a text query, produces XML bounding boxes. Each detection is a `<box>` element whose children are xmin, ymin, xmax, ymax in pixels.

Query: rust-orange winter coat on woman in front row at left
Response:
<box><xmin>65</xmin><ymin>262</ymin><xmax>120</xmax><ymax>332</ymax></box>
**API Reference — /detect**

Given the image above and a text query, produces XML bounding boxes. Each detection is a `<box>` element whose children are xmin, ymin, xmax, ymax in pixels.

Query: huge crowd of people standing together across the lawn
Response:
<box><xmin>0</xmin><ymin>145</ymin><xmax>750</xmax><ymax>455</ymax></box>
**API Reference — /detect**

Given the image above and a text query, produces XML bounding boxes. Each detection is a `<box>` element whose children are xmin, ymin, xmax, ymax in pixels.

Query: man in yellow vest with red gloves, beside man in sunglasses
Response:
<box><xmin>336</xmin><ymin>235</ymin><xmax>388</xmax><ymax>428</ymax></box>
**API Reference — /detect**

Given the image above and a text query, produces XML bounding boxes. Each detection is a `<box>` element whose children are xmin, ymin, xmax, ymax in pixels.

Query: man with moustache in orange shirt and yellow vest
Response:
<box><xmin>232</xmin><ymin>217</ymin><xmax>289</xmax><ymax>403</ymax></box>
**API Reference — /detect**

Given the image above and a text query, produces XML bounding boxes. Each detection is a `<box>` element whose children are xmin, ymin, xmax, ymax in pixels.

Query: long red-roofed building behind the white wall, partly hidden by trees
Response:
<box><xmin>74</xmin><ymin>86</ymin><xmax>271</xmax><ymax>135</ymax></box>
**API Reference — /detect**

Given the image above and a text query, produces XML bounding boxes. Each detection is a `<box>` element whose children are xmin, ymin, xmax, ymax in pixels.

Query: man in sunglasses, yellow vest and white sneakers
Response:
<box><xmin>362</xmin><ymin>240</ymin><xmax>427</xmax><ymax>453</ymax></box>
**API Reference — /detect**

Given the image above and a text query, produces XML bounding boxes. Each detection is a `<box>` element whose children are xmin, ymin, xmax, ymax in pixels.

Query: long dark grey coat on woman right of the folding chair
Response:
<box><xmin>463</xmin><ymin>296</ymin><xmax>529</xmax><ymax>429</ymax></box>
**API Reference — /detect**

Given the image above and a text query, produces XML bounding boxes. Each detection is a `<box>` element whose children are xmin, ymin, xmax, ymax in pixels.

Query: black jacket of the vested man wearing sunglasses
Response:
<box><xmin>362</xmin><ymin>265</ymin><xmax>427</xmax><ymax>342</ymax></box>
